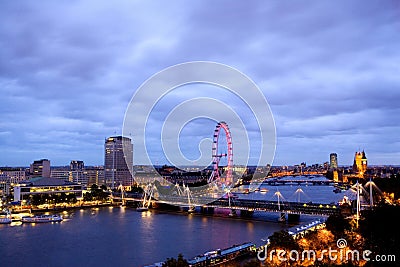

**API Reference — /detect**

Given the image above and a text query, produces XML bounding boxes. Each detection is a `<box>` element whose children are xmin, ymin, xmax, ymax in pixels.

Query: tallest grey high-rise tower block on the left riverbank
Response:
<box><xmin>104</xmin><ymin>136</ymin><xmax>133</xmax><ymax>189</ymax></box>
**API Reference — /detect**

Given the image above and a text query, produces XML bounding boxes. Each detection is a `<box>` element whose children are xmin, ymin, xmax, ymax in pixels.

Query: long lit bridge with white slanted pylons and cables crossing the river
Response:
<box><xmin>113</xmin><ymin>178</ymin><xmax>388</xmax><ymax>222</ymax></box>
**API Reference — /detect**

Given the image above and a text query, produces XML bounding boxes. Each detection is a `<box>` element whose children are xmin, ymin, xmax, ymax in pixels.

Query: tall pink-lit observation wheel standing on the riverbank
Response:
<box><xmin>212</xmin><ymin>121</ymin><xmax>233</xmax><ymax>185</ymax></box>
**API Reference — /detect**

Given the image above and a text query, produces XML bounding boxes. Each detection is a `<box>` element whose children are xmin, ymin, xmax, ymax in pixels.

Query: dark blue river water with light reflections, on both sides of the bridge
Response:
<box><xmin>0</xmin><ymin>177</ymin><xmax>350</xmax><ymax>266</ymax></box>
